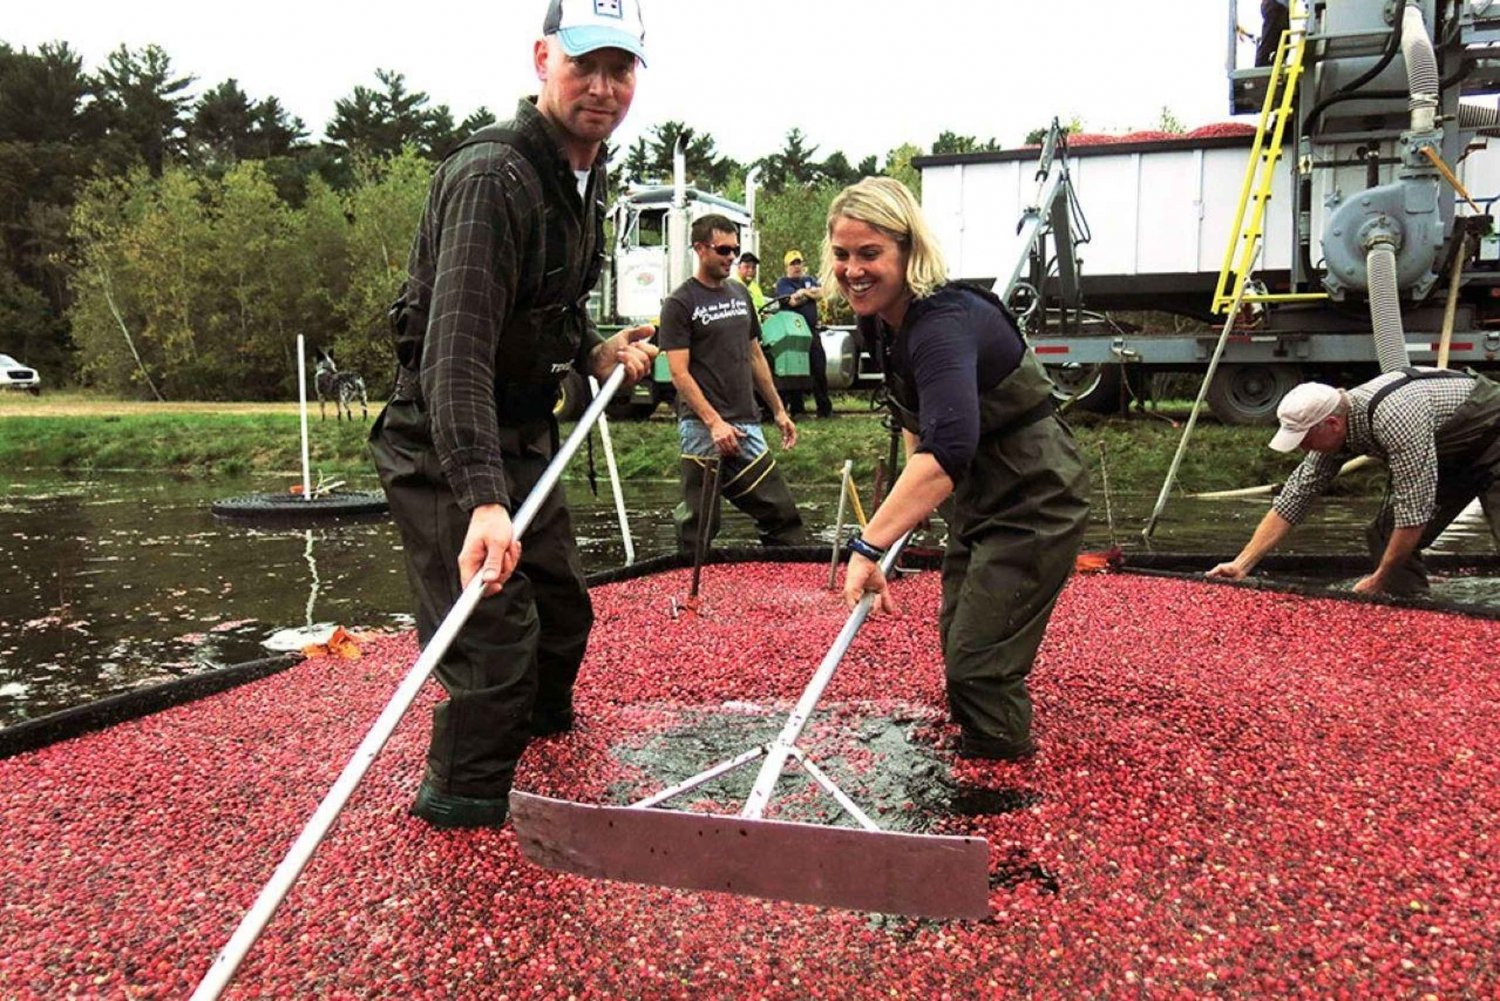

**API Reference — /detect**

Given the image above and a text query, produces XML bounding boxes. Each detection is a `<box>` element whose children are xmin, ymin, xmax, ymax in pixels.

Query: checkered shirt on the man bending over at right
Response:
<box><xmin>1274</xmin><ymin>372</ymin><xmax>1475</xmax><ymax>528</ymax></box>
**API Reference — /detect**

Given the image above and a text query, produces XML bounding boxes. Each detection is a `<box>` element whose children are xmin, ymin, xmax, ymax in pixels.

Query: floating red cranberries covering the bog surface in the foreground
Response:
<box><xmin>0</xmin><ymin>563</ymin><xmax>1500</xmax><ymax>998</ymax></box>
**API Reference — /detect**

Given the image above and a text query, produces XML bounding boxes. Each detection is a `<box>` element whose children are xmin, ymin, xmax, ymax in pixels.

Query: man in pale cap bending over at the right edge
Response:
<box><xmin>1208</xmin><ymin>368</ymin><xmax>1500</xmax><ymax>596</ymax></box>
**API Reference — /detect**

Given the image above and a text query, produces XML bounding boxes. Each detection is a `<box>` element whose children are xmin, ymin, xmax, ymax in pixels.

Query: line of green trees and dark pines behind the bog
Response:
<box><xmin>0</xmin><ymin>42</ymin><xmax>1092</xmax><ymax>399</ymax></box>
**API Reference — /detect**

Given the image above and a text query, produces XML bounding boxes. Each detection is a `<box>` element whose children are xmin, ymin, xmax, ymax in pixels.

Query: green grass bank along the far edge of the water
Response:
<box><xmin>0</xmin><ymin>399</ymin><xmax>1382</xmax><ymax>492</ymax></box>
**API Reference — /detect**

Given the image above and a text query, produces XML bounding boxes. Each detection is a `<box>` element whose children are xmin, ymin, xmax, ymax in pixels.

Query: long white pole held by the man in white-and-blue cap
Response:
<box><xmin>192</xmin><ymin>365</ymin><xmax>626</xmax><ymax>1001</ymax></box>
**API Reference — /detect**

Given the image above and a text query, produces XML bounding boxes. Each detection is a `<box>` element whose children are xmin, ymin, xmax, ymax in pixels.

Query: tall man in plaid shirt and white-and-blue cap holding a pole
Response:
<box><xmin>371</xmin><ymin>0</ymin><xmax>656</xmax><ymax>827</ymax></box>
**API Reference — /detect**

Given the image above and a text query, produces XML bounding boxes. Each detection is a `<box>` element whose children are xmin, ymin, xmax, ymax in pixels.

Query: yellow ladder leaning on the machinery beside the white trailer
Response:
<box><xmin>1214</xmin><ymin>3</ymin><xmax>1328</xmax><ymax>314</ymax></box>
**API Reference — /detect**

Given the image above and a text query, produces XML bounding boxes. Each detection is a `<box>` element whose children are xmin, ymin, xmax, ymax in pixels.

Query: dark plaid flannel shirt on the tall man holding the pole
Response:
<box><xmin>407</xmin><ymin>101</ymin><xmax>605</xmax><ymax>510</ymax></box>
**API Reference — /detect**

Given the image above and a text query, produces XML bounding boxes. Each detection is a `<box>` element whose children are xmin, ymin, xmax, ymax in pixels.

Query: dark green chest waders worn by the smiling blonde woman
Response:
<box><xmin>885</xmin><ymin>287</ymin><xmax>1089</xmax><ymax>758</ymax></box>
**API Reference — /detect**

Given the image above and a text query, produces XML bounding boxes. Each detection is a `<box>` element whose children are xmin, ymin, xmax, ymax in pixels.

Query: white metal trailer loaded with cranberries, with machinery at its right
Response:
<box><xmin>915</xmin><ymin>0</ymin><xmax>1500</xmax><ymax>423</ymax></box>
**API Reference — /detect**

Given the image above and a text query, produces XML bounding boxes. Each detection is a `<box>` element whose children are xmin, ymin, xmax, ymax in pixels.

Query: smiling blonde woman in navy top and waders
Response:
<box><xmin>822</xmin><ymin>177</ymin><xmax>1089</xmax><ymax>761</ymax></box>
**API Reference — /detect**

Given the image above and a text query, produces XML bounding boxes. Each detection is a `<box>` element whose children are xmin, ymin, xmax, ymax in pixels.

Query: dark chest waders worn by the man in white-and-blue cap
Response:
<box><xmin>371</xmin><ymin>126</ymin><xmax>603</xmax><ymax>827</ymax></box>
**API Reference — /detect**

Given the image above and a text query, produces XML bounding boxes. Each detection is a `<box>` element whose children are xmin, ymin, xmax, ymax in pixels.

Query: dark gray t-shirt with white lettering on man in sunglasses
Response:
<box><xmin>659</xmin><ymin>278</ymin><xmax>761</xmax><ymax>423</ymax></box>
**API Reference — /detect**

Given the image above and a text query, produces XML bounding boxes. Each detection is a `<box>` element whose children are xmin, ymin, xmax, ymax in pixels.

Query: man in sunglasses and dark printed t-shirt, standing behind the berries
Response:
<box><xmin>659</xmin><ymin>215</ymin><xmax>807</xmax><ymax>552</ymax></box>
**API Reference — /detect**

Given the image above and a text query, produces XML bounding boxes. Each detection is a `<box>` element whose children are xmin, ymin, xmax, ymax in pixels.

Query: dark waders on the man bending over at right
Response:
<box><xmin>1365</xmin><ymin>368</ymin><xmax>1500</xmax><ymax>596</ymax></box>
